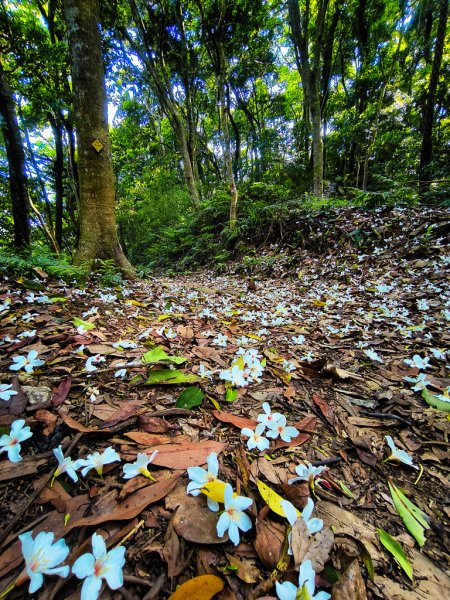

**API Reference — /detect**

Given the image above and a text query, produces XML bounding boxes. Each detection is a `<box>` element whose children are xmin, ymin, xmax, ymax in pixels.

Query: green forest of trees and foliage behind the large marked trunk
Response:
<box><xmin>0</xmin><ymin>0</ymin><xmax>450</xmax><ymax>267</ymax></box>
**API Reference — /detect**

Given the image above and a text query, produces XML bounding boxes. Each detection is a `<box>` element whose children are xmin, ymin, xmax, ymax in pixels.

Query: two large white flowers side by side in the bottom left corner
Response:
<box><xmin>15</xmin><ymin>531</ymin><xmax>126</xmax><ymax>600</ymax></box>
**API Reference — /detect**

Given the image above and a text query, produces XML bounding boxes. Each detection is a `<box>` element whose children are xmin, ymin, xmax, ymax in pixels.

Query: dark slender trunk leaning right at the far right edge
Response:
<box><xmin>418</xmin><ymin>0</ymin><xmax>448</xmax><ymax>192</ymax></box>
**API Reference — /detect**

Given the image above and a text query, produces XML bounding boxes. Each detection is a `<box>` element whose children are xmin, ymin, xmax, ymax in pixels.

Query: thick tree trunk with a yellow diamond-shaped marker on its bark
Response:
<box><xmin>64</xmin><ymin>0</ymin><xmax>134</xmax><ymax>276</ymax></box>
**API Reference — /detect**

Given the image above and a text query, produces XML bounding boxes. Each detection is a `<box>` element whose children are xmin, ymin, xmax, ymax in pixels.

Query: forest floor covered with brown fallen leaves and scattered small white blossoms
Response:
<box><xmin>0</xmin><ymin>207</ymin><xmax>450</xmax><ymax>600</ymax></box>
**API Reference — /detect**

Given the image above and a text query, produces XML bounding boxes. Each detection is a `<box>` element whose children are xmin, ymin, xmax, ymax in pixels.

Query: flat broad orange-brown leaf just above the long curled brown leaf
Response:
<box><xmin>152</xmin><ymin>440</ymin><xmax>225</xmax><ymax>469</ymax></box>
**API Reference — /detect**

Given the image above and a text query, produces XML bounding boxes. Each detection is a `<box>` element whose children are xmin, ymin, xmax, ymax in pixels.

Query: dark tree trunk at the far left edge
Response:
<box><xmin>0</xmin><ymin>57</ymin><xmax>30</xmax><ymax>248</ymax></box>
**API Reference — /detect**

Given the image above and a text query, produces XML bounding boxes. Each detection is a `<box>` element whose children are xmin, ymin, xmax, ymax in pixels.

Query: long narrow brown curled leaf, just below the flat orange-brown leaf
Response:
<box><xmin>72</xmin><ymin>477</ymin><xmax>178</xmax><ymax>527</ymax></box>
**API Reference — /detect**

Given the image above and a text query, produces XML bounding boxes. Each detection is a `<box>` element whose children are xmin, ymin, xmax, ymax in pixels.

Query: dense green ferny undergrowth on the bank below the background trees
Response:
<box><xmin>129</xmin><ymin>181</ymin><xmax>426</xmax><ymax>275</ymax></box>
